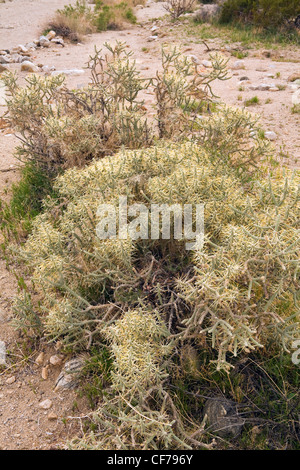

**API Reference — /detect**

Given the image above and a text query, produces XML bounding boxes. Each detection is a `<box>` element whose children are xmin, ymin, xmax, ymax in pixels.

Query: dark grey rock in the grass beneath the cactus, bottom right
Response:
<box><xmin>204</xmin><ymin>397</ymin><xmax>244</xmax><ymax>437</ymax></box>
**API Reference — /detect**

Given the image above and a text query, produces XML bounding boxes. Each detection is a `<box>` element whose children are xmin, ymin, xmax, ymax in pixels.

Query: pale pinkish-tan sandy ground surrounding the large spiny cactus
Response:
<box><xmin>0</xmin><ymin>0</ymin><xmax>300</xmax><ymax>449</ymax></box>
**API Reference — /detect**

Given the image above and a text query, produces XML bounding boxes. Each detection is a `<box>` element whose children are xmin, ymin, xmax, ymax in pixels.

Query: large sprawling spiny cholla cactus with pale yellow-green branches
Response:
<box><xmin>1</xmin><ymin>4</ymin><xmax>300</xmax><ymax>450</ymax></box>
